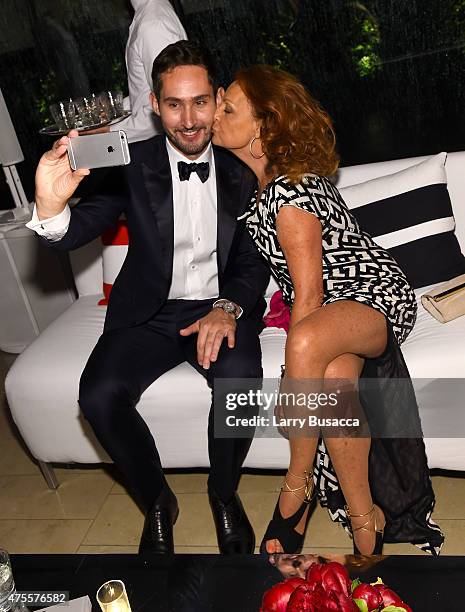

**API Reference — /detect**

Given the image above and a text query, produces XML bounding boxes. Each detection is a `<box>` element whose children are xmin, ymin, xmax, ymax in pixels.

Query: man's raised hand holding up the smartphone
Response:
<box><xmin>35</xmin><ymin>130</ymin><xmax>90</xmax><ymax>220</ymax></box>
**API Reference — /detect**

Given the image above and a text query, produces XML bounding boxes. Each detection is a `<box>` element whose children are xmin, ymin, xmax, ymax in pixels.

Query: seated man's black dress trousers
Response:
<box><xmin>79</xmin><ymin>299</ymin><xmax>262</xmax><ymax>510</ymax></box>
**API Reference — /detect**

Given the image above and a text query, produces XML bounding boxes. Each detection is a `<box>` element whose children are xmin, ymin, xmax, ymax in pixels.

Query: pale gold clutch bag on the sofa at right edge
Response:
<box><xmin>421</xmin><ymin>274</ymin><xmax>465</xmax><ymax>323</ymax></box>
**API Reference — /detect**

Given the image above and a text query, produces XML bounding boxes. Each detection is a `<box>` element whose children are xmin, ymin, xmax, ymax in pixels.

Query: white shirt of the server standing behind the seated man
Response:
<box><xmin>110</xmin><ymin>0</ymin><xmax>187</xmax><ymax>142</ymax></box>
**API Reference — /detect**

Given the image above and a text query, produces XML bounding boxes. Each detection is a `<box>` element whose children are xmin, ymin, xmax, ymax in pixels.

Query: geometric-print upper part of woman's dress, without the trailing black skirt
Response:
<box><xmin>241</xmin><ymin>176</ymin><xmax>417</xmax><ymax>344</ymax></box>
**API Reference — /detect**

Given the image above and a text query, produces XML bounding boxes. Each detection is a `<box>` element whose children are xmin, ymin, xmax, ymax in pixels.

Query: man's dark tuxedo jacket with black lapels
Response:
<box><xmin>49</xmin><ymin>136</ymin><xmax>269</xmax><ymax>330</ymax></box>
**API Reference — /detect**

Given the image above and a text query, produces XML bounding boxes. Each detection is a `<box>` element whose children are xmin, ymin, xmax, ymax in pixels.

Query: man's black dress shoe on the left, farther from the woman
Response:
<box><xmin>139</xmin><ymin>486</ymin><xmax>179</xmax><ymax>554</ymax></box>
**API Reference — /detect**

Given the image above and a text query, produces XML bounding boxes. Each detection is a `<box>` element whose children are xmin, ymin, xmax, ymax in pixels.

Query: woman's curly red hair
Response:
<box><xmin>236</xmin><ymin>65</ymin><xmax>339</xmax><ymax>183</ymax></box>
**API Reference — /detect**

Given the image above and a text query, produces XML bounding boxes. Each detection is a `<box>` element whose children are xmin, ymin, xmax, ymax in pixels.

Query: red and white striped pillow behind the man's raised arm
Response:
<box><xmin>98</xmin><ymin>219</ymin><xmax>129</xmax><ymax>306</ymax></box>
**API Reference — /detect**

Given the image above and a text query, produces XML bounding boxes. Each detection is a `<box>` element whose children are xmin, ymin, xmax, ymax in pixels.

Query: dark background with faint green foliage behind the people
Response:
<box><xmin>0</xmin><ymin>0</ymin><xmax>465</xmax><ymax>208</ymax></box>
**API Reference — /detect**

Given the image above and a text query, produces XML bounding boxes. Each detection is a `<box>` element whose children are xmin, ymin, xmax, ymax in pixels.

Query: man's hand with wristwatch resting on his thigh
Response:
<box><xmin>179</xmin><ymin>308</ymin><xmax>236</xmax><ymax>370</ymax></box>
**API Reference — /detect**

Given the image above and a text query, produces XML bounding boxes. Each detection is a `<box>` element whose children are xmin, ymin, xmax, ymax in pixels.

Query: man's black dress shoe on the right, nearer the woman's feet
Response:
<box><xmin>208</xmin><ymin>491</ymin><xmax>255</xmax><ymax>555</ymax></box>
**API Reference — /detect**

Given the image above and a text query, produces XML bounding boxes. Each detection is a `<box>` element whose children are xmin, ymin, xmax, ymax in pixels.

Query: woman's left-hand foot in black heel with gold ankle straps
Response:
<box><xmin>262</xmin><ymin>471</ymin><xmax>313</xmax><ymax>554</ymax></box>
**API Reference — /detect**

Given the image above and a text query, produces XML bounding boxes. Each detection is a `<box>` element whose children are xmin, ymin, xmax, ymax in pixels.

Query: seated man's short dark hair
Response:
<box><xmin>152</xmin><ymin>40</ymin><xmax>218</xmax><ymax>100</ymax></box>
